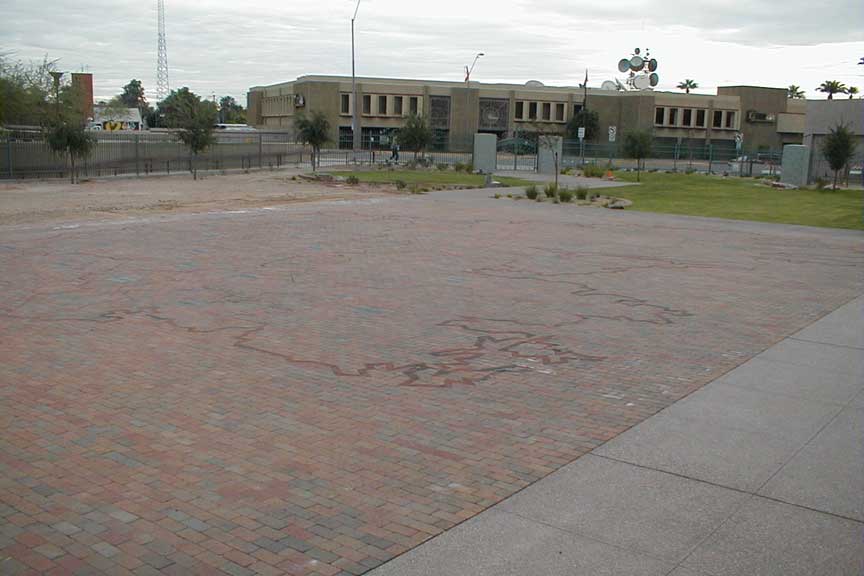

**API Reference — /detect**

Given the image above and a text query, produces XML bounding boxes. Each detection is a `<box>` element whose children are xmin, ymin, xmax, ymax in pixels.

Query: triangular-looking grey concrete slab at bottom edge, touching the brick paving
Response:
<box><xmin>368</xmin><ymin>509</ymin><xmax>672</xmax><ymax>576</ymax></box>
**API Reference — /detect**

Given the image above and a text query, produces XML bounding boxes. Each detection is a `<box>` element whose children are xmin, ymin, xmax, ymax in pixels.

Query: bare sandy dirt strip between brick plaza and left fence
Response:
<box><xmin>0</xmin><ymin>170</ymin><xmax>389</xmax><ymax>225</ymax></box>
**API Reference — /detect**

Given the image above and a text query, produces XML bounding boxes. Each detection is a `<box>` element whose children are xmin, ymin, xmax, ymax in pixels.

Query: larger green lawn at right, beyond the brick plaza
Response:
<box><xmin>604</xmin><ymin>172</ymin><xmax>864</xmax><ymax>230</ymax></box>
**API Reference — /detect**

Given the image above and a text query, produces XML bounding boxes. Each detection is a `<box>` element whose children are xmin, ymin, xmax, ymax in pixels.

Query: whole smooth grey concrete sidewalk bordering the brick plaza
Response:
<box><xmin>370</xmin><ymin>297</ymin><xmax>864</xmax><ymax>576</ymax></box>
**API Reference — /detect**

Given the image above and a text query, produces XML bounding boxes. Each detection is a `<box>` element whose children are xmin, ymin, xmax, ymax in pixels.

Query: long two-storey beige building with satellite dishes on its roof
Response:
<box><xmin>248</xmin><ymin>76</ymin><xmax>806</xmax><ymax>151</ymax></box>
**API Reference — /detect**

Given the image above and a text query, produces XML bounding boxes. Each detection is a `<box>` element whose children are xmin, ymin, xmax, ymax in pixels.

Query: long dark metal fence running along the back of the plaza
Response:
<box><xmin>0</xmin><ymin>131</ymin><xmax>781</xmax><ymax>178</ymax></box>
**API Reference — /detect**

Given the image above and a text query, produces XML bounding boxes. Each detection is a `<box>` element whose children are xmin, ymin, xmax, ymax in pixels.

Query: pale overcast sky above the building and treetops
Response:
<box><xmin>0</xmin><ymin>0</ymin><xmax>864</xmax><ymax>104</ymax></box>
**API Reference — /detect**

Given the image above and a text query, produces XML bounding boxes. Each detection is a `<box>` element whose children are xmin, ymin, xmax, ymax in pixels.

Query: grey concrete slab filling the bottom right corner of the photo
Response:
<box><xmin>684</xmin><ymin>496</ymin><xmax>864</xmax><ymax>576</ymax></box>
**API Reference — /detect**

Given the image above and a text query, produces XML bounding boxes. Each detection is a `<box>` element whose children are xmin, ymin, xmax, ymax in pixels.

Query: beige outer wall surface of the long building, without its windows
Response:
<box><xmin>248</xmin><ymin>76</ymin><xmax>803</xmax><ymax>147</ymax></box>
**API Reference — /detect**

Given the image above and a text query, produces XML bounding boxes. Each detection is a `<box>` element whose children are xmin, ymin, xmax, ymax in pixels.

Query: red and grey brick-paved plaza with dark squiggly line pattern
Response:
<box><xmin>0</xmin><ymin>192</ymin><xmax>864</xmax><ymax>576</ymax></box>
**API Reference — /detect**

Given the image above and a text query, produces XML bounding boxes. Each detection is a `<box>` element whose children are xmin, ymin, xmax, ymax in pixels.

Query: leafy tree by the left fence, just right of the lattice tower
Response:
<box><xmin>159</xmin><ymin>87</ymin><xmax>216</xmax><ymax>178</ymax></box>
